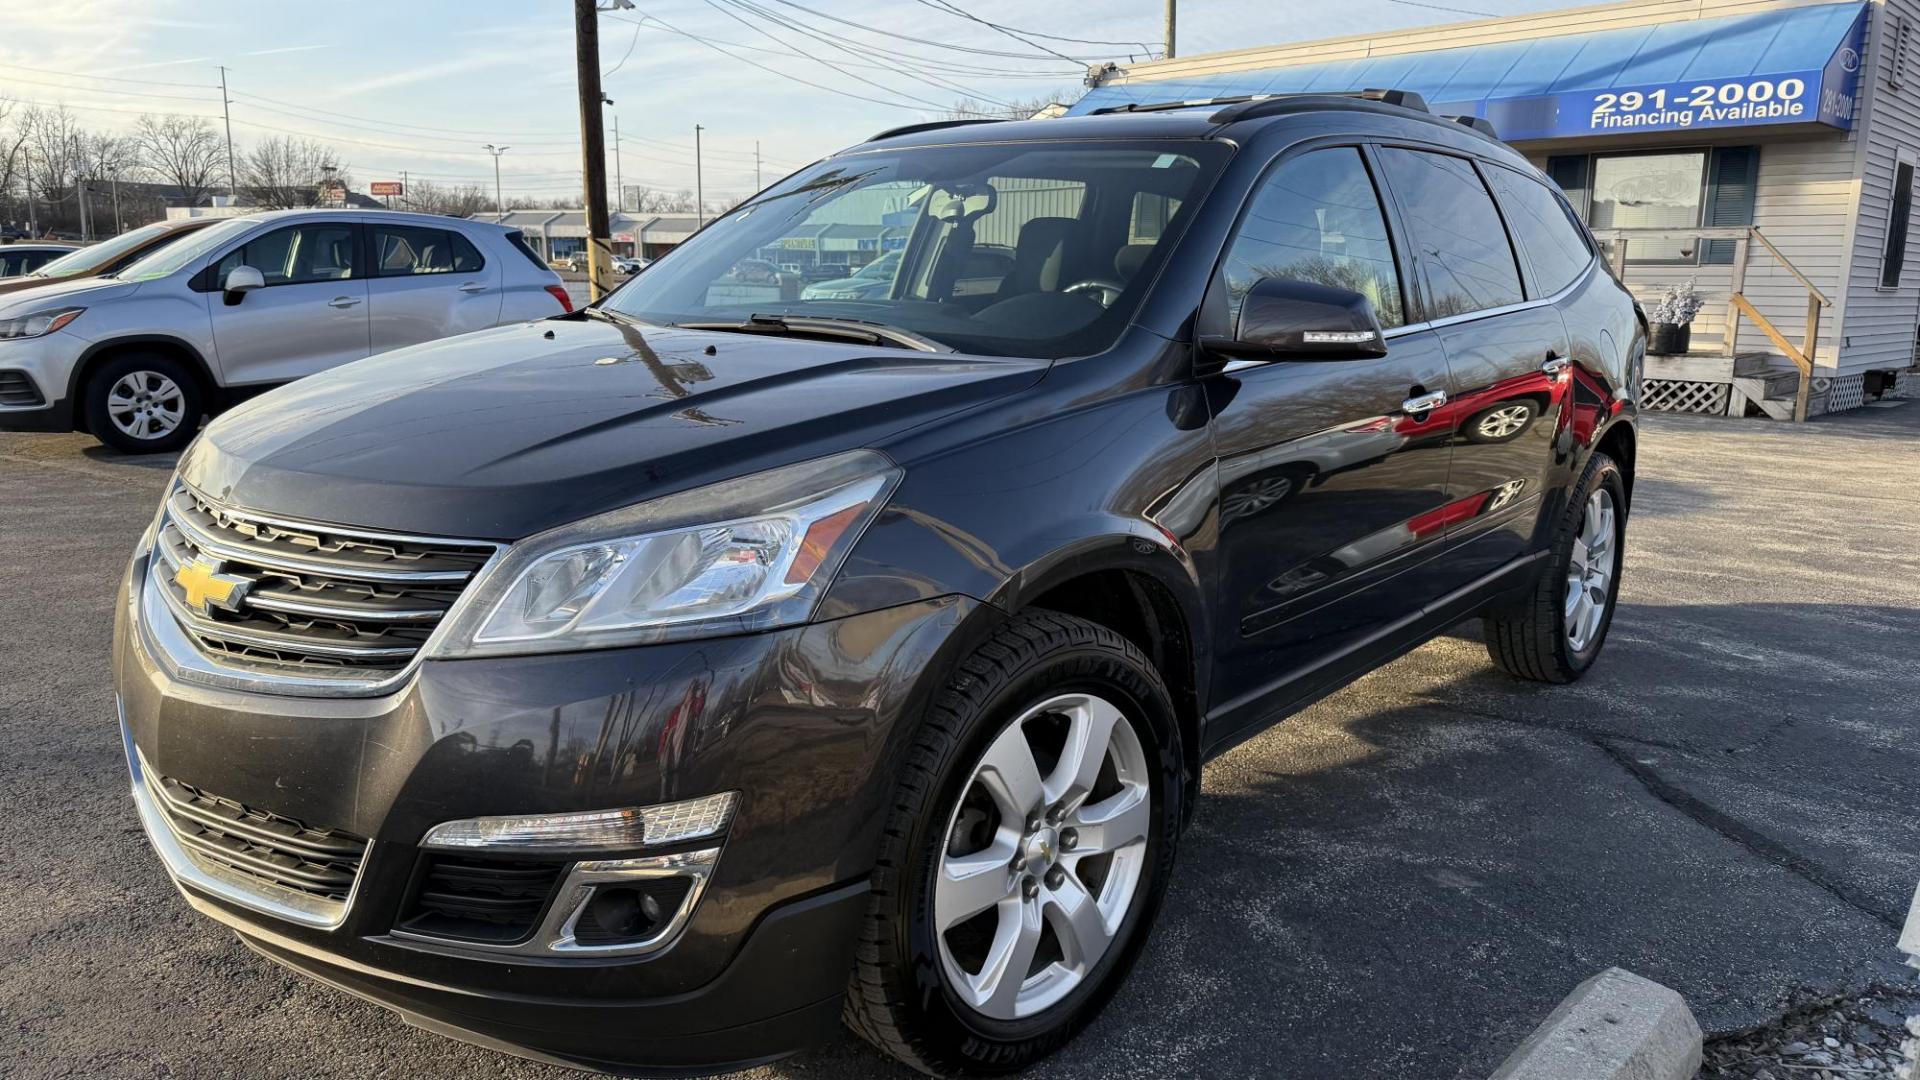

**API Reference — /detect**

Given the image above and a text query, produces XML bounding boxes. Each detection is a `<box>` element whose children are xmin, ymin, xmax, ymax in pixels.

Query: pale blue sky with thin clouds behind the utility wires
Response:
<box><xmin>0</xmin><ymin>0</ymin><xmax>1567</xmax><ymax>202</ymax></box>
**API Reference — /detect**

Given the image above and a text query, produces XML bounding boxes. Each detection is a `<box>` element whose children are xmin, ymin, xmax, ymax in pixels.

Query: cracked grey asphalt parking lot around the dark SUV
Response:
<box><xmin>0</xmin><ymin>402</ymin><xmax>1920</xmax><ymax>1080</ymax></box>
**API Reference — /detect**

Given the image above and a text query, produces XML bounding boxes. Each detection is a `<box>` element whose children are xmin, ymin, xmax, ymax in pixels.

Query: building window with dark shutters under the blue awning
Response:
<box><xmin>1546</xmin><ymin>146</ymin><xmax>1761</xmax><ymax>265</ymax></box>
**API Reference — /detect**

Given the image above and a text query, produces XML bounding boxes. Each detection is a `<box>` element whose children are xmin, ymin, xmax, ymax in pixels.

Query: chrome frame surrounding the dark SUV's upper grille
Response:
<box><xmin>132</xmin><ymin>480</ymin><xmax>509</xmax><ymax>698</ymax></box>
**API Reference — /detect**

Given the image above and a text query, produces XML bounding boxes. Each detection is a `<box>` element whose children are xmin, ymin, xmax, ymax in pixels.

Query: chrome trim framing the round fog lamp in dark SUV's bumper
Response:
<box><xmin>388</xmin><ymin>846</ymin><xmax>720</xmax><ymax>963</ymax></box>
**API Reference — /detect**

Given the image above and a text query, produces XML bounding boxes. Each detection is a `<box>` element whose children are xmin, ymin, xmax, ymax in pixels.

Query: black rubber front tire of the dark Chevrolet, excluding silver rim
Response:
<box><xmin>845</xmin><ymin>611</ymin><xmax>1185</xmax><ymax>1076</ymax></box>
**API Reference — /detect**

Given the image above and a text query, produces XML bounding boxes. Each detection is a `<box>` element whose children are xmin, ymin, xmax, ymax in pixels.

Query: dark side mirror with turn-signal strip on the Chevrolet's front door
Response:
<box><xmin>1202</xmin><ymin>277</ymin><xmax>1386</xmax><ymax>359</ymax></box>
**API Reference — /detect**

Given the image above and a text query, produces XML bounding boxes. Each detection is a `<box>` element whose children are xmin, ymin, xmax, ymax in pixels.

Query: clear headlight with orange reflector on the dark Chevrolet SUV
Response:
<box><xmin>432</xmin><ymin>450</ymin><xmax>900</xmax><ymax>659</ymax></box>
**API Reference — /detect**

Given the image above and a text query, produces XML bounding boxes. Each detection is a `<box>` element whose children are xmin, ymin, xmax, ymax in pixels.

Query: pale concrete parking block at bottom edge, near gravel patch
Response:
<box><xmin>1492</xmin><ymin>967</ymin><xmax>1701</xmax><ymax>1080</ymax></box>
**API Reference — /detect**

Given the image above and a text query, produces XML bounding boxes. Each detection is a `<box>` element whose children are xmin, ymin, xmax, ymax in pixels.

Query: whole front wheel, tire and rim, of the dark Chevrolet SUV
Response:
<box><xmin>847</xmin><ymin>611</ymin><xmax>1183</xmax><ymax>1074</ymax></box>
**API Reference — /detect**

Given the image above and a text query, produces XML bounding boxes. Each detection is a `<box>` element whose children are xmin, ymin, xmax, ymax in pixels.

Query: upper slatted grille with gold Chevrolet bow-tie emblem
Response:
<box><xmin>152</xmin><ymin>484</ymin><xmax>497</xmax><ymax>682</ymax></box>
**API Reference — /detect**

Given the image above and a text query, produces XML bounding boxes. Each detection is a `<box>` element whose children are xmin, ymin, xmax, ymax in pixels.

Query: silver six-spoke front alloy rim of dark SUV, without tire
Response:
<box><xmin>933</xmin><ymin>694</ymin><xmax>1154</xmax><ymax>1020</ymax></box>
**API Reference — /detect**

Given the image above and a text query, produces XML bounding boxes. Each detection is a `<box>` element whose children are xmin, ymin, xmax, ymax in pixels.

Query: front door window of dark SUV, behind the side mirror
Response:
<box><xmin>1221</xmin><ymin>146</ymin><xmax>1407</xmax><ymax>327</ymax></box>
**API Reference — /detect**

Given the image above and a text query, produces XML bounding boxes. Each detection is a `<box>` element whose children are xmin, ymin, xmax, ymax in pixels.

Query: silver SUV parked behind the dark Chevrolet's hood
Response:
<box><xmin>0</xmin><ymin>209</ymin><xmax>572</xmax><ymax>452</ymax></box>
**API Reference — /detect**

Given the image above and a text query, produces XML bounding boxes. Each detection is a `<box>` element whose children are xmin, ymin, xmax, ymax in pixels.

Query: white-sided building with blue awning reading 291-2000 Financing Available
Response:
<box><xmin>1071</xmin><ymin>0</ymin><xmax>1920</xmax><ymax>417</ymax></box>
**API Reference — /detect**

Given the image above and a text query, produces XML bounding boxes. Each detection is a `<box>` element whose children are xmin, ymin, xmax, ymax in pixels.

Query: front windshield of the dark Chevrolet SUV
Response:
<box><xmin>603</xmin><ymin>140</ymin><xmax>1231</xmax><ymax>357</ymax></box>
